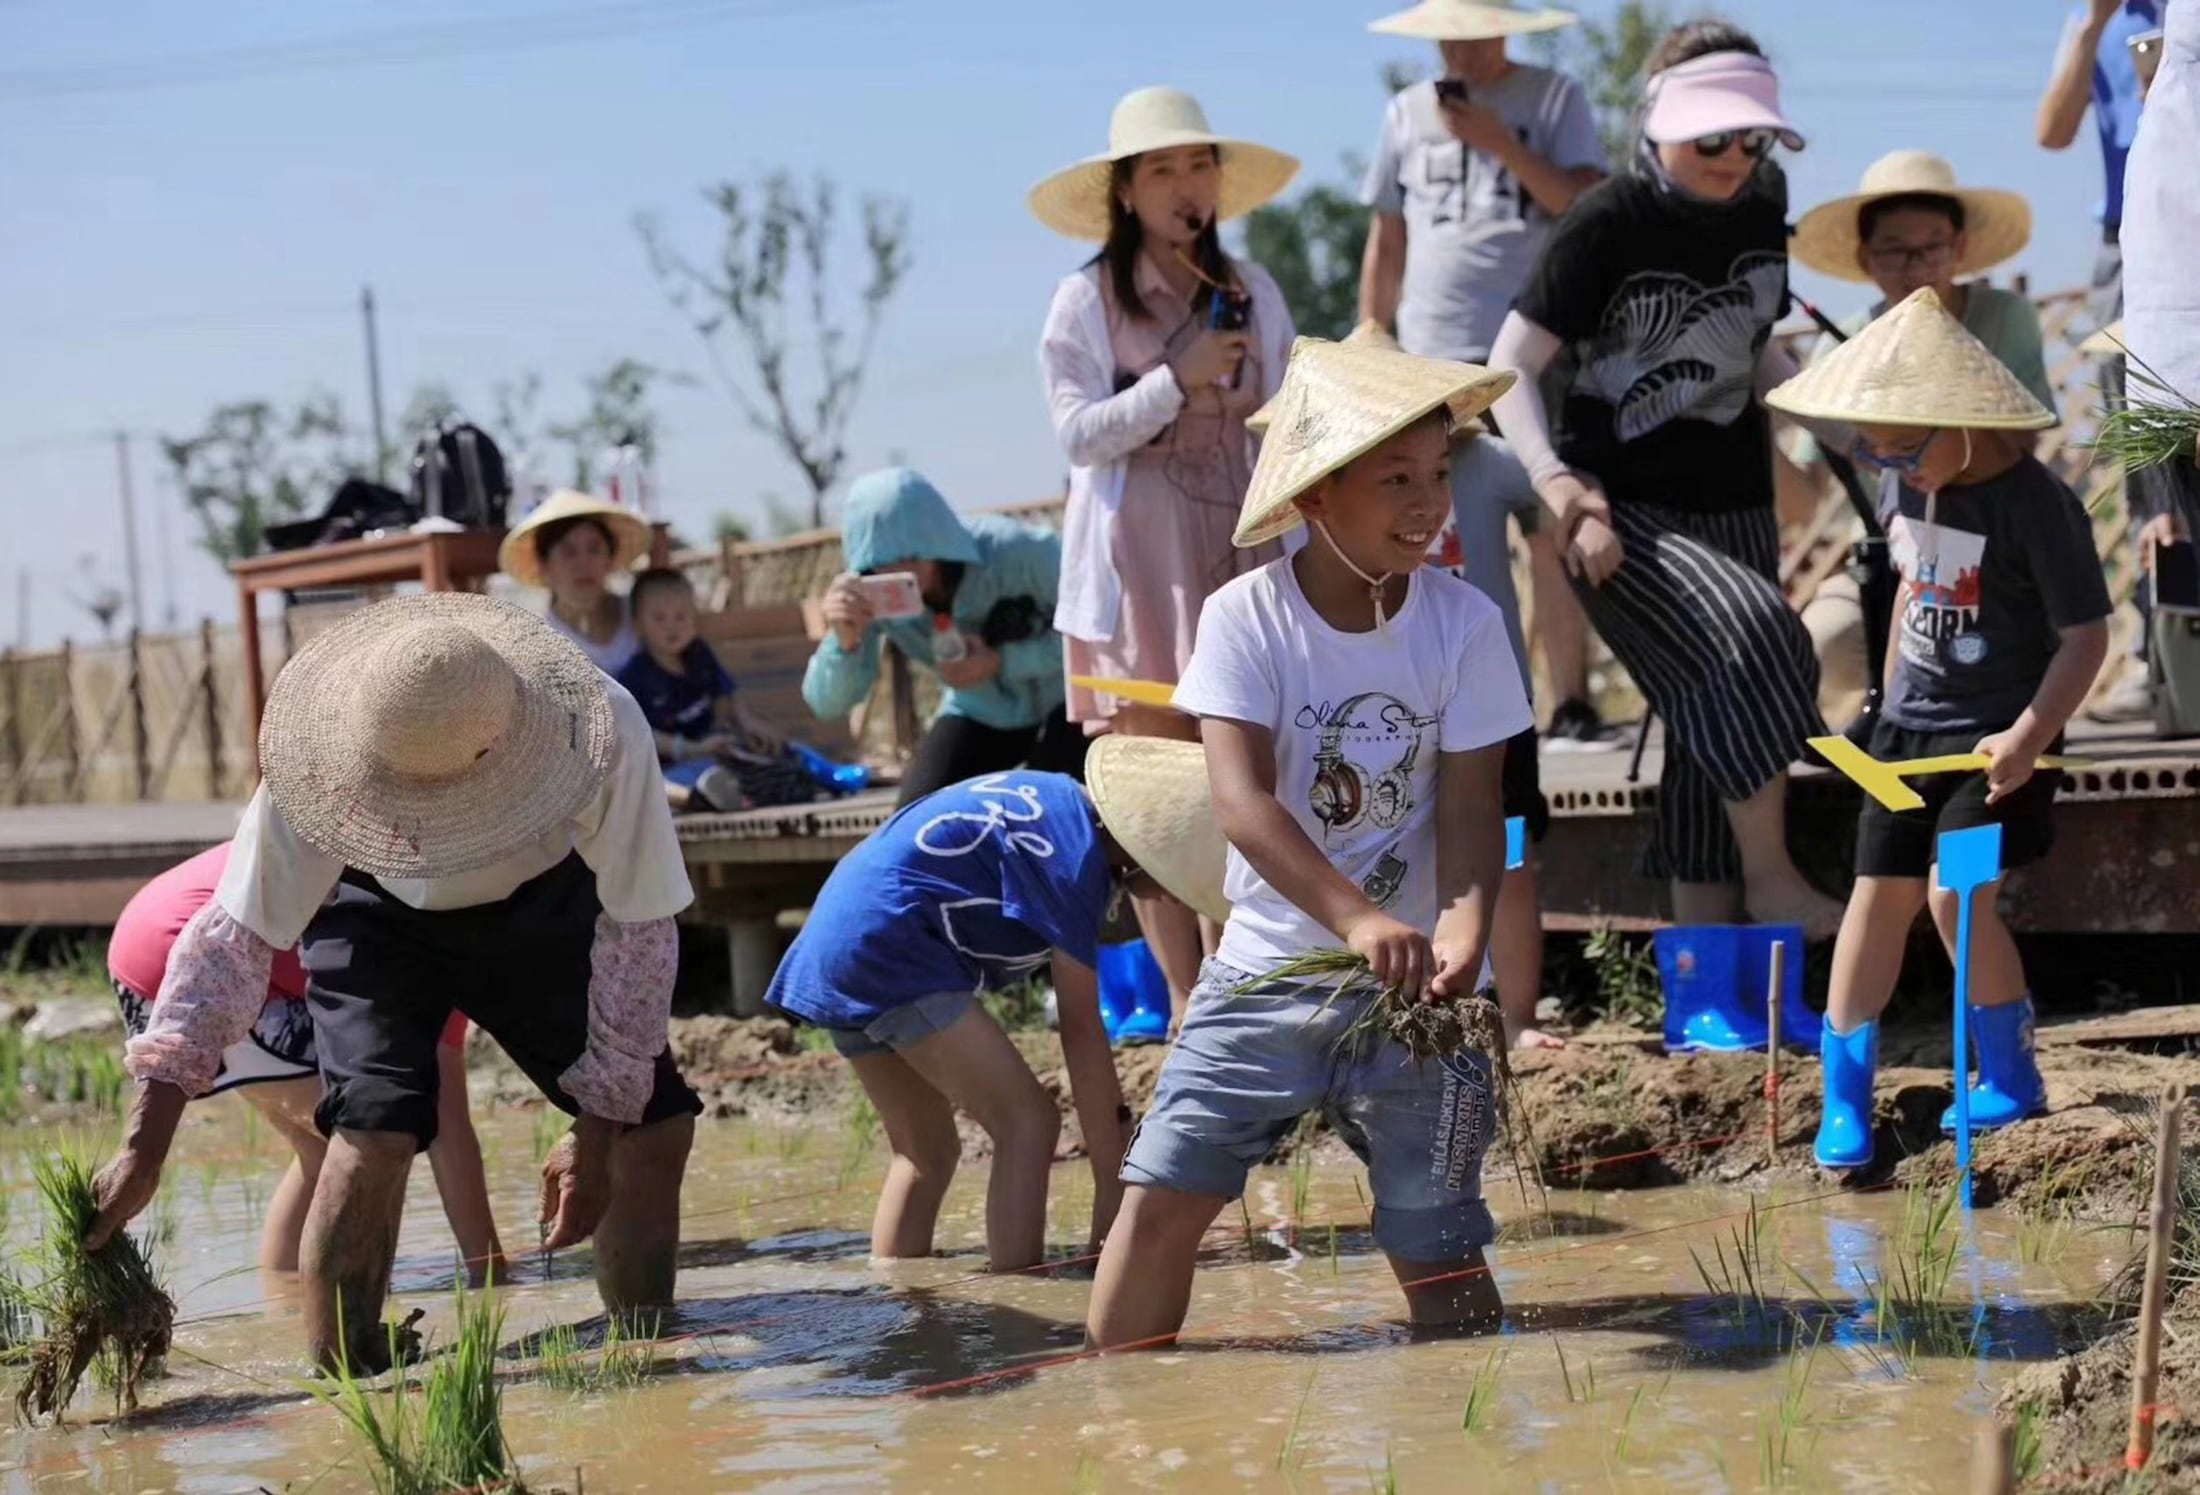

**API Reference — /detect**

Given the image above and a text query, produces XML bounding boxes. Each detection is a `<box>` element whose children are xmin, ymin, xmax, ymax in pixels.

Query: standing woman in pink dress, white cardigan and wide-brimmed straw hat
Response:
<box><xmin>1032</xmin><ymin>88</ymin><xmax>1298</xmax><ymax>1018</ymax></box>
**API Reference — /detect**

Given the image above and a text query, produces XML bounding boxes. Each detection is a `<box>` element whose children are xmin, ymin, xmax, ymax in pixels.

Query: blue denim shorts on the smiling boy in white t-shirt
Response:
<box><xmin>1122</xmin><ymin>961</ymin><xmax>1496</xmax><ymax>1262</ymax></box>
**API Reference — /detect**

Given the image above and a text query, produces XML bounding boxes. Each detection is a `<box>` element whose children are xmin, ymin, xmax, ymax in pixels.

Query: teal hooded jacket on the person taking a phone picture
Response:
<box><xmin>803</xmin><ymin>468</ymin><xmax>1065</xmax><ymax>732</ymax></box>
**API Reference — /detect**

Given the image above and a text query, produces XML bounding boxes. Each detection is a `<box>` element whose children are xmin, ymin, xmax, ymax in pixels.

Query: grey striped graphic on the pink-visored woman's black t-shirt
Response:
<box><xmin>1575</xmin><ymin>251</ymin><xmax>1786</xmax><ymax>442</ymax></box>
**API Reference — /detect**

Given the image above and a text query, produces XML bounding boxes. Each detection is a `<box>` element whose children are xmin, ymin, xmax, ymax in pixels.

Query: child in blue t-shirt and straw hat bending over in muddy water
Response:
<box><xmin>766</xmin><ymin>737</ymin><xmax>1221</xmax><ymax>1271</ymax></box>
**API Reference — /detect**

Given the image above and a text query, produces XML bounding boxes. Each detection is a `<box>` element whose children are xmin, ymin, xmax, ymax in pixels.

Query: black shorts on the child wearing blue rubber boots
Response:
<box><xmin>1857</xmin><ymin>721</ymin><xmax>2061</xmax><ymax>877</ymax></box>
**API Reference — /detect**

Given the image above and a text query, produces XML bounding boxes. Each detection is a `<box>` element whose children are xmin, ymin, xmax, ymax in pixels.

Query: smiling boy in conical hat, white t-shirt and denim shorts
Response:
<box><xmin>1087</xmin><ymin>339</ymin><xmax>1531</xmax><ymax>1348</ymax></box>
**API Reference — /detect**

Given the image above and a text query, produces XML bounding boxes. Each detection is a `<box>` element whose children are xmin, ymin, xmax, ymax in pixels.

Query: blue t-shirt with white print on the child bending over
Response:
<box><xmin>763</xmin><ymin>772</ymin><xmax>1111</xmax><ymax>1029</ymax></box>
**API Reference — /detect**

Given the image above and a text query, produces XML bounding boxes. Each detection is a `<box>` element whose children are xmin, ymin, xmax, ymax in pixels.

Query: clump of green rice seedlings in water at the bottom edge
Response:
<box><xmin>308</xmin><ymin>1282</ymin><xmax>526</xmax><ymax>1495</ymax></box>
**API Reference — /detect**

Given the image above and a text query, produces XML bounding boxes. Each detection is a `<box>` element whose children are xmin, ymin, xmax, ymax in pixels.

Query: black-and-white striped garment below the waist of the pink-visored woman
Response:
<box><xmin>1575</xmin><ymin>503</ymin><xmax>1826</xmax><ymax>882</ymax></box>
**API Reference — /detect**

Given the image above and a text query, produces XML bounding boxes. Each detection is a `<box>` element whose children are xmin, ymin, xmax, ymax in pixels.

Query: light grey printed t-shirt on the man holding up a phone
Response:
<box><xmin>1360</xmin><ymin>64</ymin><xmax>1604</xmax><ymax>363</ymax></box>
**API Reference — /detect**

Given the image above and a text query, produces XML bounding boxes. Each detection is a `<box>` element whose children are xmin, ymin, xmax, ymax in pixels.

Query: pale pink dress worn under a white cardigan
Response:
<box><xmin>1063</xmin><ymin>257</ymin><xmax>1283</xmax><ymax>723</ymax></box>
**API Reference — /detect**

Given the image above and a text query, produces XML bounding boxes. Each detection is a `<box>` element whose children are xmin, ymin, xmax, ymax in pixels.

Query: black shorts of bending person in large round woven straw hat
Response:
<box><xmin>304</xmin><ymin>855</ymin><xmax>702</xmax><ymax>1148</ymax></box>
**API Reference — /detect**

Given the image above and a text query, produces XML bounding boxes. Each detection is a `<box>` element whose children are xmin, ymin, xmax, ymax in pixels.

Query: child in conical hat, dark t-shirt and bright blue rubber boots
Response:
<box><xmin>1767</xmin><ymin>290</ymin><xmax>2110</xmax><ymax>1170</ymax></box>
